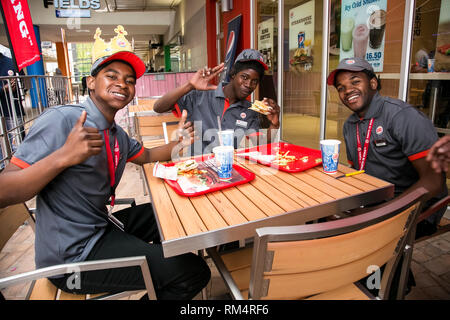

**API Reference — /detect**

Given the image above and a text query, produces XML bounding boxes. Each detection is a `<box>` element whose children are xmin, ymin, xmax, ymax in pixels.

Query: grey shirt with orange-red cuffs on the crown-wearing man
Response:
<box><xmin>11</xmin><ymin>98</ymin><xmax>144</xmax><ymax>268</ymax></box>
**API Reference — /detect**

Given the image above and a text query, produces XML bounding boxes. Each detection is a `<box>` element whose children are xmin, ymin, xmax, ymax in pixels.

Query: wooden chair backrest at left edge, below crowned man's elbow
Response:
<box><xmin>0</xmin><ymin>203</ymin><xmax>31</xmax><ymax>251</ymax></box>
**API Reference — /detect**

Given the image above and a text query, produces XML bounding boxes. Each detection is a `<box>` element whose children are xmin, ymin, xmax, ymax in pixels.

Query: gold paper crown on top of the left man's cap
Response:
<box><xmin>92</xmin><ymin>25</ymin><xmax>133</xmax><ymax>62</ymax></box>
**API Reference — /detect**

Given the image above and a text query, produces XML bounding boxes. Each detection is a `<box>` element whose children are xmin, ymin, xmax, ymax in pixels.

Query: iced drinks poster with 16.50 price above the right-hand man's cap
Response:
<box><xmin>339</xmin><ymin>0</ymin><xmax>387</xmax><ymax>72</ymax></box>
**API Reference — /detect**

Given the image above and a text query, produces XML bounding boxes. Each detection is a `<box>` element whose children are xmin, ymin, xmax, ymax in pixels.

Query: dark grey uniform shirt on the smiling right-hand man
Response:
<box><xmin>343</xmin><ymin>93</ymin><xmax>447</xmax><ymax>222</ymax></box>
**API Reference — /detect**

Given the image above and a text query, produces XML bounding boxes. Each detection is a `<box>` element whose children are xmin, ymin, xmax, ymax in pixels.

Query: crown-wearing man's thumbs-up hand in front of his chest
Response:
<box><xmin>62</xmin><ymin>111</ymin><xmax>103</xmax><ymax>167</ymax></box>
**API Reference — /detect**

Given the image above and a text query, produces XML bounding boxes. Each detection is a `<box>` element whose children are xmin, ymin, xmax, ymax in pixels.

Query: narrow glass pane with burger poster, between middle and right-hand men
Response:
<box><xmin>281</xmin><ymin>0</ymin><xmax>323</xmax><ymax>149</ymax></box>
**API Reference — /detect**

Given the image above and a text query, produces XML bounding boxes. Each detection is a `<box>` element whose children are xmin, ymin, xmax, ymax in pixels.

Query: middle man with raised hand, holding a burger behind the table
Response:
<box><xmin>153</xmin><ymin>49</ymin><xmax>280</xmax><ymax>154</ymax></box>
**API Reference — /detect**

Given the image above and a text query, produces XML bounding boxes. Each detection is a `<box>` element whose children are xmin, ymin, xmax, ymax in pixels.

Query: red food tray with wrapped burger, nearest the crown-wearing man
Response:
<box><xmin>164</xmin><ymin>155</ymin><xmax>255</xmax><ymax>197</ymax></box>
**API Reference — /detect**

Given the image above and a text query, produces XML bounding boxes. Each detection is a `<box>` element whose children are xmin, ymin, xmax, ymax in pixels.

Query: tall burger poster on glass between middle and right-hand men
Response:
<box><xmin>289</xmin><ymin>0</ymin><xmax>315</xmax><ymax>72</ymax></box>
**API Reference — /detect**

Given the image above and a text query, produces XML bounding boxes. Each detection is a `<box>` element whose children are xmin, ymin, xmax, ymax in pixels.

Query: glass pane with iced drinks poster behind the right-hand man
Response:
<box><xmin>326</xmin><ymin>0</ymin><xmax>405</xmax><ymax>164</ymax></box>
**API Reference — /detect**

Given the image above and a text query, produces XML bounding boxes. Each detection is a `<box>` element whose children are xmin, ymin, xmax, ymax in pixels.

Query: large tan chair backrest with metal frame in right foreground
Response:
<box><xmin>249</xmin><ymin>188</ymin><xmax>427</xmax><ymax>299</ymax></box>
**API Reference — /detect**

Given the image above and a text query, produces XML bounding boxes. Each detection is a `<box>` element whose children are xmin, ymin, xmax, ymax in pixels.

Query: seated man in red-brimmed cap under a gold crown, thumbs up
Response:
<box><xmin>0</xmin><ymin>52</ymin><xmax>210</xmax><ymax>299</ymax></box>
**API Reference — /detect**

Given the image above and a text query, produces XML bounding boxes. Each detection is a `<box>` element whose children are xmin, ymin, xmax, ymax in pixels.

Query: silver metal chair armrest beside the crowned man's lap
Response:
<box><xmin>0</xmin><ymin>256</ymin><xmax>156</xmax><ymax>300</ymax></box>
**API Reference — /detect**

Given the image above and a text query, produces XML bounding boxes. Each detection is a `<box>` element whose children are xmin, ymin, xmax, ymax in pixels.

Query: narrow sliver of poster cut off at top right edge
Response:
<box><xmin>434</xmin><ymin>0</ymin><xmax>450</xmax><ymax>72</ymax></box>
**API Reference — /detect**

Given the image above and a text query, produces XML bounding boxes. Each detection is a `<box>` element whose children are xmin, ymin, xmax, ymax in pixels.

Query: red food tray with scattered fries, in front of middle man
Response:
<box><xmin>236</xmin><ymin>142</ymin><xmax>322</xmax><ymax>172</ymax></box>
